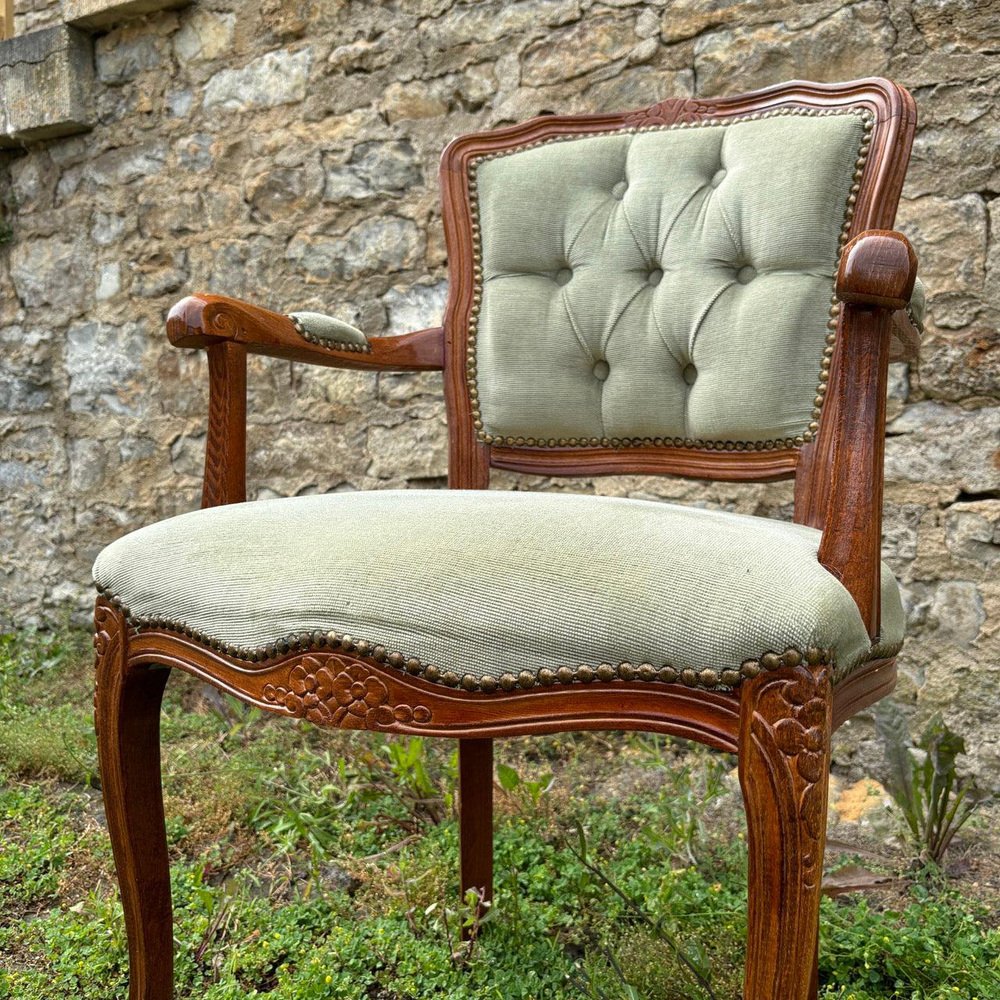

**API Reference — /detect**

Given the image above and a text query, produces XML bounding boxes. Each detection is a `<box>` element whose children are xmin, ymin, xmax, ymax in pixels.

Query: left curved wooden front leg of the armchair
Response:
<box><xmin>94</xmin><ymin>600</ymin><xmax>173</xmax><ymax>1000</ymax></box>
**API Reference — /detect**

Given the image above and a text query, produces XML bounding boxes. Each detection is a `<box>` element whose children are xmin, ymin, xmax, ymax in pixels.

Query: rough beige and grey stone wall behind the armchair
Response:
<box><xmin>0</xmin><ymin>0</ymin><xmax>1000</xmax><ymax>785</ymax></box>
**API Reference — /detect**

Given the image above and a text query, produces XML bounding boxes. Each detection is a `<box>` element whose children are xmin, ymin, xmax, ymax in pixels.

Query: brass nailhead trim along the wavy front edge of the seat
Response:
<box><xmin>97</xmin><ymin>587</ymin><xmax>856</xmax><ymax>692</ymax></box>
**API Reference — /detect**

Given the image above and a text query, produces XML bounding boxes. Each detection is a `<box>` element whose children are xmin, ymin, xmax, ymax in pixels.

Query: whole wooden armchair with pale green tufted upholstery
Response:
<box><xmin>94</xmin><ymin>79</ymin><xmax>918</xmax><ymax>1000</ymax></box>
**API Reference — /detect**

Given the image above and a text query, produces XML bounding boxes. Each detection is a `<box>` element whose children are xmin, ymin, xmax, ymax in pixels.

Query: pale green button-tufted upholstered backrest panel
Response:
<box><xmin>469</xmin><ymin>108</ymin><xmax>872</xmax><ymax>449</ymax></box>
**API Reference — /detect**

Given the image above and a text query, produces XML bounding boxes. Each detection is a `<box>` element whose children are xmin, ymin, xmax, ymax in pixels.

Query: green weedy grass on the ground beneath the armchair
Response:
<box><xmin>0</xmin><ymin>629</ymin><xmax>1000</xmax><ymax>1000</ymax></box>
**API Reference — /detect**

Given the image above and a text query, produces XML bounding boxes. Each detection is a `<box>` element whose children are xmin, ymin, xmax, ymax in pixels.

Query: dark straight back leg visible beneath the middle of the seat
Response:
<box><xmin>458</xmin><ymin>740</ymin><xmax>493</xmax><ymax>924</ymax></box>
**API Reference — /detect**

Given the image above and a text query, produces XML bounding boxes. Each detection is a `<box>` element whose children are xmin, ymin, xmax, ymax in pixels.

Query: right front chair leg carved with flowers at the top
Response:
<box><xmin>739</xmin><ymin>664</ymin><xmax>832</xmax><ymax>1000</ymax></box>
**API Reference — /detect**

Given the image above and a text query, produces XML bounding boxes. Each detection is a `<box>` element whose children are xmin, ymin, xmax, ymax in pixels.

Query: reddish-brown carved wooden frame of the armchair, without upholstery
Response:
<box><xmin>95</xmin><ymin>79</ymin><xmax>918</xmax><ymax>1000</ymax></box>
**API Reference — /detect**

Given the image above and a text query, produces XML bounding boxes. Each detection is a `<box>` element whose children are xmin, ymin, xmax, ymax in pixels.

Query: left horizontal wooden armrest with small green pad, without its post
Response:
<box><xmin>167</xmin><ymin>294</ymin><xmax>444</xmax><ymax>371</ymax></box>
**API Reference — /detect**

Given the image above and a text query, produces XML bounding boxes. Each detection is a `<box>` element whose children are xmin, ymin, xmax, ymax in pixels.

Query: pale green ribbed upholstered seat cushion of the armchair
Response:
<box><xmin>94</xmin><ymin>490</ymin><xmax>903</xmax><ymax>690</ymax></box>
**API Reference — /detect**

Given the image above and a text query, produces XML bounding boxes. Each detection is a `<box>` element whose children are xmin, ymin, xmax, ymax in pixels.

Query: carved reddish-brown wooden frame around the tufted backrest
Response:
<box><xmin>440</xmin><ymin>79</ymin><xmax>916</xmax><ymax>496</ymax></box>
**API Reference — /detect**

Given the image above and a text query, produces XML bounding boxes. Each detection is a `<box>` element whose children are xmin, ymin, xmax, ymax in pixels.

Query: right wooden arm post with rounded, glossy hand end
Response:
<box><xmin>819</xmin><ymin>230</ymin><xmax>917</xmax><ymax>638</ymax></box>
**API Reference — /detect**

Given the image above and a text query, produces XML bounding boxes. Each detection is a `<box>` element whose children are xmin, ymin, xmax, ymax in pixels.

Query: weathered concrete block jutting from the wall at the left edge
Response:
<box><xmin>0</xmin><ymin>25</ymin><xmax>94</xmax><ymax>146</ymax></box>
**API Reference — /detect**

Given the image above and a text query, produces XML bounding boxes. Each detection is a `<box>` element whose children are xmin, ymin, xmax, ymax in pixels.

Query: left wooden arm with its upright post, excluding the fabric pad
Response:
<box><xmin>167</xmin><ymin>295</ymin><xmax>444</xmax><ymax>507</ymax></box>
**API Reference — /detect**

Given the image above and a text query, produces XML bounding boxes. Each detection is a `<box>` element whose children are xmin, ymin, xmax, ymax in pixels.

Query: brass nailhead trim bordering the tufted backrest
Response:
<box><xmin>466</xmin><ymin>102</ymin><xmax>875</xmax><ymax>451</ymax></box>
